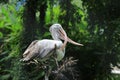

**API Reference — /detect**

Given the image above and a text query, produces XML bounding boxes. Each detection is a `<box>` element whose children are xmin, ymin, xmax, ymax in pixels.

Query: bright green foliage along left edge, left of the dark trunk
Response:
<box><xmin>0</xmin><ymin>3</ymin><xmax>22</xmax><ymax>80</ymax></box>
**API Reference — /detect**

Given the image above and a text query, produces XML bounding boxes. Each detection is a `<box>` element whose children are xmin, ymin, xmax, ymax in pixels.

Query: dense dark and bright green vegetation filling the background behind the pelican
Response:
<box><xmin>0</xmin><ymin>0</ymin><xmax>120</xmax><ymax>80</ymax></box>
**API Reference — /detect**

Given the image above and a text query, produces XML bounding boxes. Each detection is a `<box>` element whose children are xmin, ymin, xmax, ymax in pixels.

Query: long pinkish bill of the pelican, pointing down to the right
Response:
<box><xmin>59</xmin><ymin>29</ymin><xmax>83</xmax><ymax>48</ymax></box>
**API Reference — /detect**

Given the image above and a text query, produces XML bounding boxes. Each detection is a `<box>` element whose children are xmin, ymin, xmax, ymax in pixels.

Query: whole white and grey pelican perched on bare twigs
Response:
<box><xmin>21</xmin><ymin>24</ymin><xmax>83</xmax><ymax>61</ymax></box>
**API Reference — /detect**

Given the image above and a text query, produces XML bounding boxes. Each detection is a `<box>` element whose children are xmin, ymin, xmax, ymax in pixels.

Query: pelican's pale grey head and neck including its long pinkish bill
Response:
<box><xmin>49</xmin><ymin>24</ymin><xmax>83</xmax><ymax>48</ymax></box>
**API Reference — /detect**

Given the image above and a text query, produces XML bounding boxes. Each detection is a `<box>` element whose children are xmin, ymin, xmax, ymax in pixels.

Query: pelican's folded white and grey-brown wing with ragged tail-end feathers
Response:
<box><xmin>22</xmin><ymin>40</ymin><xmax>59</xmax><ymax>61</ymax></box>
